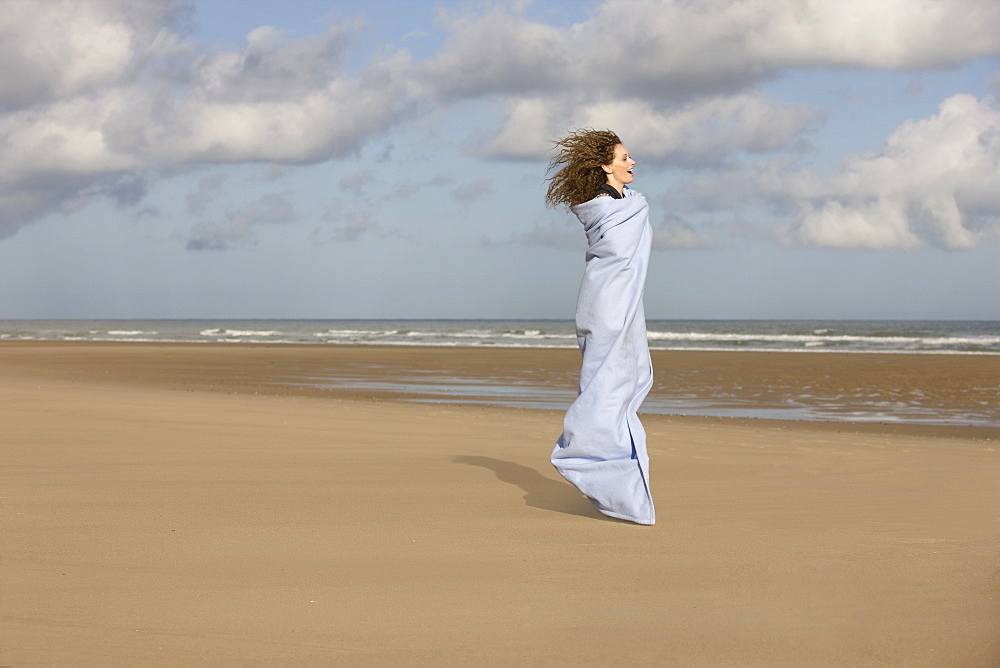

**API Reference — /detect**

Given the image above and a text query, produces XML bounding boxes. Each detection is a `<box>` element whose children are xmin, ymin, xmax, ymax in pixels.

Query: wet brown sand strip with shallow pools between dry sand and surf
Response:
<box><xmin>0</xmin><ymin>341</ymin><xmax>1000</xmax><ymax>438</ymax></box>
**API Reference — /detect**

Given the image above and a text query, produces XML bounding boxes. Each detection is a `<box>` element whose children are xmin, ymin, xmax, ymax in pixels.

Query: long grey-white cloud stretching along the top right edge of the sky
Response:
<box><xmin>422</xmin><ymin>0</ymin><xmax>1000</xmax><ymax>101</ymax></box>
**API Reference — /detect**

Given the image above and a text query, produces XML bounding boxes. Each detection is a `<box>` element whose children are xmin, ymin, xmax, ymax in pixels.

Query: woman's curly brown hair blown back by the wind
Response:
<box><xmin>545</xmin><ymin>128</ymin><xmax>622</xmax><ymax>207</ymax></box>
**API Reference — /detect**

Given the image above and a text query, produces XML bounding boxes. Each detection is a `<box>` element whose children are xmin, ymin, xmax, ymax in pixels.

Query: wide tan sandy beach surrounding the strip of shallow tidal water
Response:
<box><xmin>0</xmin><ymin>342</ymin><xmax>1000</xmax><ymax>666</ymax></box>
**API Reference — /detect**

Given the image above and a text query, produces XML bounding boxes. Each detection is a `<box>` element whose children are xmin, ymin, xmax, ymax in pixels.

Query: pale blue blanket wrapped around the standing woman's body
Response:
<box><xmin>552</xmin><ymin>188</ymin><xmax>656</xmax><ymax>524</ymax></box>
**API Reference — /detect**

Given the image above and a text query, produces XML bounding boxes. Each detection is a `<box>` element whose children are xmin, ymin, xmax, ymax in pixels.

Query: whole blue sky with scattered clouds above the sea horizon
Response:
<box><xmin>0</xmin><ymin>0</ymin><xmax>1000</xmax><ymax>320</ymax></box>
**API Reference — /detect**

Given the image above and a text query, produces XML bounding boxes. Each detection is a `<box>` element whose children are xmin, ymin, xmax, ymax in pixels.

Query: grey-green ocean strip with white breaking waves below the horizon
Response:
<box><xmin>0</xmin><ymin>320</ymin><xmax>1000</xmax><ymax>354</ymax></box>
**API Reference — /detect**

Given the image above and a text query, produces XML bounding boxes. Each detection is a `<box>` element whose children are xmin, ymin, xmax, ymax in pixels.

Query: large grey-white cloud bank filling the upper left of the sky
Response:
<box><xmin>0</xmin><ymin>0</ymin><xmax>414</xmax><ymax>236</ymax></box>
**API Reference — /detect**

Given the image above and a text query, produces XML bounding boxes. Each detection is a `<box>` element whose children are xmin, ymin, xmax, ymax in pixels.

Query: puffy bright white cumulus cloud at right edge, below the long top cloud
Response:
<box><xmin>793</xmin><ymin>95</ymin><xmax>1000</xmax><ymax>249</ymax></box>
